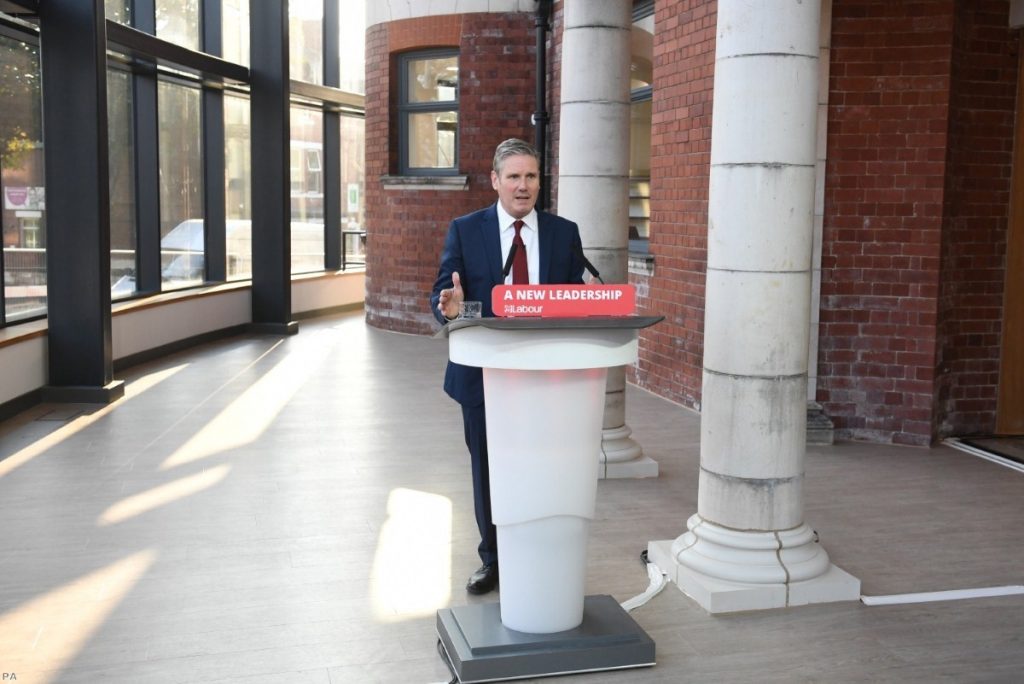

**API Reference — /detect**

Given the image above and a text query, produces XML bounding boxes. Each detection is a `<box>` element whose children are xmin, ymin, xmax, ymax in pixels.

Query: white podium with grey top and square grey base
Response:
<box><xmin>437</xmin><ymin>316</ymin><xmax>662</xmax><ymax>683</ymax></box>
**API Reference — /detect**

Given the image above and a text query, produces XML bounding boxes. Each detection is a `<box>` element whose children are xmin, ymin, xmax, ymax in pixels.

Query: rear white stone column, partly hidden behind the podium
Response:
<box><xmin>558</xmin><ymin>0</ymin><xmax>657</xmax><ymax>477</ymax></box>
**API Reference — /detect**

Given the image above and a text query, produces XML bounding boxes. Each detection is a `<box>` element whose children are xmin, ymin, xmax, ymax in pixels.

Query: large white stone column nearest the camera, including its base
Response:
<box><xmin>650</xmin><ymin>0</ymin><xmax>860</xmax><ymax>612</ymax></box>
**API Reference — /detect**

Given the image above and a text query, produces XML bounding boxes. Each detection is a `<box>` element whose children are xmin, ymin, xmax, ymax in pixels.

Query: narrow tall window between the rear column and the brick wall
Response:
<box><xmin>630</xmin><ymin>0</ymin><xmax>654</xmax><ymax>252</ymax></box>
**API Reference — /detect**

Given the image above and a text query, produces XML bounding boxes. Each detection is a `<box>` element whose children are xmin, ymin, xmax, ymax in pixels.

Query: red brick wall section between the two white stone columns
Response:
<box><xmin>631</xmin><ymin>0</ymin><xmax>717</xmax><ymax>407</ymax></box>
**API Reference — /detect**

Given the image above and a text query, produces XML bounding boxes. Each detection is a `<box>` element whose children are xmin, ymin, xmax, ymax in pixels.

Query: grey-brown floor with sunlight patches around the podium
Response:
<box><xmin>0</xmin><ymin>314</ymin><xmax>1024</xmax><ymax>684</ymax></box>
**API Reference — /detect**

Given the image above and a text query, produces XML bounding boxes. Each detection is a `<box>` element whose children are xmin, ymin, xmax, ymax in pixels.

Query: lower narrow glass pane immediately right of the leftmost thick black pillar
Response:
<box><xmin>106</xmin><ymin>71</ymin><xmax>136</xmax><ymax>299</ymax></box>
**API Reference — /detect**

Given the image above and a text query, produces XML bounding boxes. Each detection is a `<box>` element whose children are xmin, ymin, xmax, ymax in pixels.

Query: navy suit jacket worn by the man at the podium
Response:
<box><xmin>430</xmin><ymin>203</ymin><xmax>584</xmax><ymax>407</ymax></box>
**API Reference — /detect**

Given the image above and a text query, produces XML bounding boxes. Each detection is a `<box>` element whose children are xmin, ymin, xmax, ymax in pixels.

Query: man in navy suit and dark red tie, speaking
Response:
<box><xmin>430</xmin><ymin>138</ymin><xmax>584</xmax><ymax>594</ymax></box>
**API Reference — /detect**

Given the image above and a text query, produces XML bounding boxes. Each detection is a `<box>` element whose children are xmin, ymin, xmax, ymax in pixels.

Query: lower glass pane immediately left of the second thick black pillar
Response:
<box><xmin>224</xmin><ymin>95</ymin><xmax>253</xmax><ymax>281</ymax></box>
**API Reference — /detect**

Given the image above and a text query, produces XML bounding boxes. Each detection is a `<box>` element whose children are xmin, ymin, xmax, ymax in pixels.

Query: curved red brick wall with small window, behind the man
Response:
<box><xmin>366</xmin><ymin>12</ymin><xmax>536</xmax><ymax>334</ymax></box>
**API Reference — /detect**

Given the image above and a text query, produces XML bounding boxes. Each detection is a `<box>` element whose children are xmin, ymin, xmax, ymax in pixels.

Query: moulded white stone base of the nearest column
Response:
<box><xmin>647</xmin><ymin>515</ymin><xmax>860</xmax><ymax>613</ymax></box>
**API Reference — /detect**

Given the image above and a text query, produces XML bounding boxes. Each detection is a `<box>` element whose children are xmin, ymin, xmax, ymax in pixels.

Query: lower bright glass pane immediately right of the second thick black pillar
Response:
<box><xmin>291</xmin><ymin>106</ymin><xmax>325</xmax><ymax>273</ymax></box>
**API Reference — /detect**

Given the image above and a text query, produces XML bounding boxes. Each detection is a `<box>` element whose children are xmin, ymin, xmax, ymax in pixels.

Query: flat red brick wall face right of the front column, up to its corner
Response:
<box><xmin>818</xmin><ymin>0</ymin><xmax>953</xmax><ymax>444</ymax></box>
